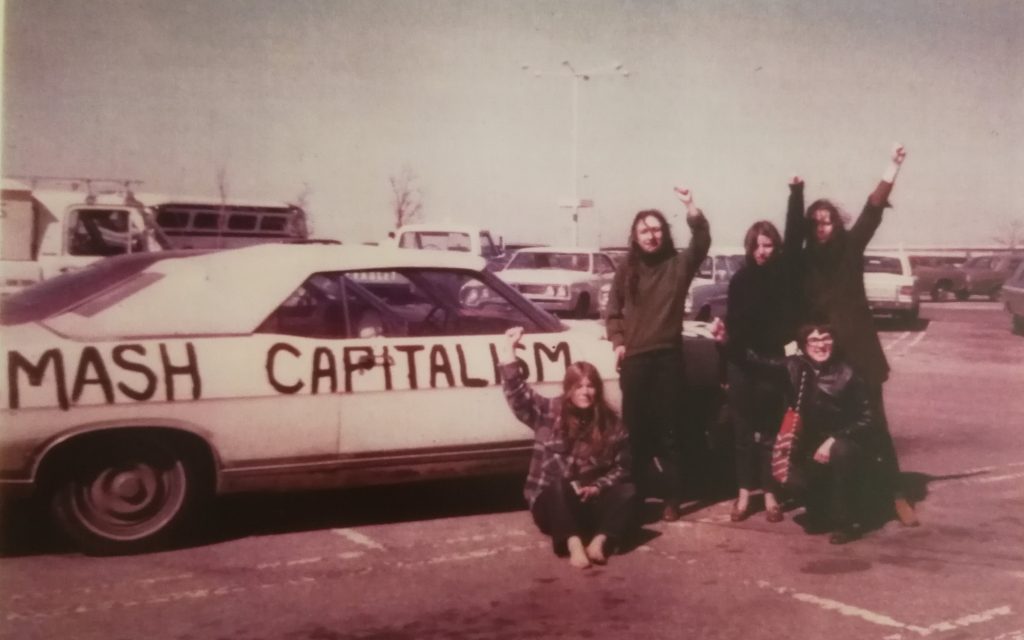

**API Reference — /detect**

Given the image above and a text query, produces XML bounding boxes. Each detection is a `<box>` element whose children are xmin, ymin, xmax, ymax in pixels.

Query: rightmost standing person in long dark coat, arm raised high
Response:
<box><xmin>786</xmin><ymin>144</ymin><xmax>919</xmax><ymax>526</ymax></box>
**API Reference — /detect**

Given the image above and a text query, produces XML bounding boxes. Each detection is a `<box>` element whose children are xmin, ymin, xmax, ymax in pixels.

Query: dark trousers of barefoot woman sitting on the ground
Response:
<box><xmin>529</xmin><ymin>480</ymin><xmax>637</xmax><ymax>548</ymax></box>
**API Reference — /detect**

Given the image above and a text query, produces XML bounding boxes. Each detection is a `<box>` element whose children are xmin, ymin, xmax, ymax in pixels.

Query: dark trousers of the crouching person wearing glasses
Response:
<box><xmin>790</xmin><ymin>438</ymin><xmax>869</xmax><ymax>528</ymax></box>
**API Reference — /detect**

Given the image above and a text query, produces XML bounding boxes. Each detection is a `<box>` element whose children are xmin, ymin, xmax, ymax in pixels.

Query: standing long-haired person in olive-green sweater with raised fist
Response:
<box><xmin>606</xmin><ymin>187</ymin><xmax>711</xmax><ymax>521</ymax></box>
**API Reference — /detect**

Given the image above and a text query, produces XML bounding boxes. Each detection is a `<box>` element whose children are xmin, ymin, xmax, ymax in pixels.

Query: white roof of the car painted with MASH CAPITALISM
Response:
<box><xmin>28</xmin><ymin>244</ymin><xmax>485</xmax><ymax>339</ymax></box>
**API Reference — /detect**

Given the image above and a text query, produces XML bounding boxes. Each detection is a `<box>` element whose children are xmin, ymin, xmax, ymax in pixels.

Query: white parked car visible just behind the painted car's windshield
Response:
<box><xmin>498</xmin><ymin>247</ymin><xmax>615</xmax><ymax>317</ymax></box>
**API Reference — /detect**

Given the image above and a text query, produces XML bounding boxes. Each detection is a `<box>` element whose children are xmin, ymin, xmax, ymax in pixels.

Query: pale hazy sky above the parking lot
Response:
<box><xmin>2</xmin><ymin>0</ymin><xmax>1024</xmax><ymax>246</ymax></box>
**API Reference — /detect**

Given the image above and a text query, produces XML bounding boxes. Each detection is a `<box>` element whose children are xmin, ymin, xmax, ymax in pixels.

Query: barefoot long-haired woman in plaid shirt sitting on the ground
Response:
<box><xmin>500</xmin><ymin>327</ymin><xmax>636</xmax><ymax>568</ymax></box>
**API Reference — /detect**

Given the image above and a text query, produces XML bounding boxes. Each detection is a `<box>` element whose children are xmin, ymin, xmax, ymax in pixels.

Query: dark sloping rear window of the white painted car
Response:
<box><xmin>0</xmin><ymin>252</ymin><xmax>190</xmax><ymax>326</ymax></box>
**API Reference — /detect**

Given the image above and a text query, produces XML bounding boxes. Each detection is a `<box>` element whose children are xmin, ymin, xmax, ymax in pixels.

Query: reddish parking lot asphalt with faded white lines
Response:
<box><xmin>0</xmin><ymin>301</ymin><xmax>1024</xmax><ymax>640</ymax></box>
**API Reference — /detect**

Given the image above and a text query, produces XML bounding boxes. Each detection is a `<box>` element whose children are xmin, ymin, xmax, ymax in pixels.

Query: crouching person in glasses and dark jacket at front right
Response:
<box><xmin>786</xmin><ymin>324</ymin><xmax>879</xmax><ymax>545</ymax></box>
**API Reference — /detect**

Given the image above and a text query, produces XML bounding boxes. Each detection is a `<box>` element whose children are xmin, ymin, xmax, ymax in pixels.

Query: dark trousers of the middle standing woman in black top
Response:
<box><xmin>726</xmin><ymin>362</ymin><xmax>785</xmax><ymax>493</ymax></box>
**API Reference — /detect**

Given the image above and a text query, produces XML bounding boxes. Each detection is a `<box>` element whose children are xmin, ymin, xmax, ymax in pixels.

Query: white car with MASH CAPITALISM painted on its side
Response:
<box><xmin>0</xmin><ymin>245</ymin><xmax>718</xmax><ymax>553</ymax></box>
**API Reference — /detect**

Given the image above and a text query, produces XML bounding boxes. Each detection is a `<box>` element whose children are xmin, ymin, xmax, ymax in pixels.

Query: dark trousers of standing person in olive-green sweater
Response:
<box><xmin>618</xmin><ymin>347</ymin><xmax>684</xmax><ymax>505</ymax></box>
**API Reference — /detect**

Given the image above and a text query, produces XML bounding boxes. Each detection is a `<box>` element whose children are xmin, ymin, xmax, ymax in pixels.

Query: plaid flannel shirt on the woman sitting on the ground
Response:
<box><xmin>501</xmin><ymin>362</ymin><xmax>630</xmax><ymax>506</ymax></box>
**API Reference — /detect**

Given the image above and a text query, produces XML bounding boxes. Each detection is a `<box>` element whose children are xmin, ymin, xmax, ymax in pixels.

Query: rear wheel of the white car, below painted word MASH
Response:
<box><xmin>50</xmin><ymin>433</ymin><xmax>202</xmax><ymax>555</ymax></box>
